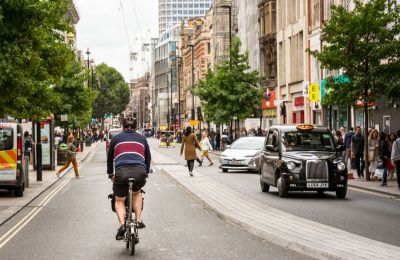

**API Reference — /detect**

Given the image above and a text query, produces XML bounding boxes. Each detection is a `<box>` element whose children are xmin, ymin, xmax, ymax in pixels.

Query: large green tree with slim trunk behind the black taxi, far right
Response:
<box><xmin>312</xmin><ymin>0</ymin><xmax>400</xmax><ymax>180</ymax></box>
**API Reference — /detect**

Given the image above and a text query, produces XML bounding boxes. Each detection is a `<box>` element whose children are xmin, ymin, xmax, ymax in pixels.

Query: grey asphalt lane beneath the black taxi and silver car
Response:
<box><xmin>149</xmin><ymin>139</ymin><xmax>400</xmax><ymax>246</ymax></box>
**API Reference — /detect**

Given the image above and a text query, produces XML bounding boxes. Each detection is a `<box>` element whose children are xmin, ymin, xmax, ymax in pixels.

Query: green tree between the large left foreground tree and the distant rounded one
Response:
<box><xmin>54</xmin><ymin>61</ymin><xmax>97</xmax><ymax>128</ymax></box>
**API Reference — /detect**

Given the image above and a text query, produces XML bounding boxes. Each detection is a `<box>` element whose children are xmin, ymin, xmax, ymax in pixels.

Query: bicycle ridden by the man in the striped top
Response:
<box><xmin>124</xmin><ymin>178</ymin><xmax>145</xmax><ymax>255</ymax></box>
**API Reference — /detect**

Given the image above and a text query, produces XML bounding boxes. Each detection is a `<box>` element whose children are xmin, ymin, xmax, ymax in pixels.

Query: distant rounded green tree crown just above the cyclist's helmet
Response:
<box><xmin>94</xmin><ymin>63</ymin><xmax>130</xmax><ymax>123</ymax></box>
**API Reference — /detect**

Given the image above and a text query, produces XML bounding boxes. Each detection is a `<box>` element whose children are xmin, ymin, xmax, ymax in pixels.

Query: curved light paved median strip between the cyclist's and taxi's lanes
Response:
<box><xmin>151</xmin><ymin>150</ymin><xmax>400</xmax><ymax>260</ymax></box>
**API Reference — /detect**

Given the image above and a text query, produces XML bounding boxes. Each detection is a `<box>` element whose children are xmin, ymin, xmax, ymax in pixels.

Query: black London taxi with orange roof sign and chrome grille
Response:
<box><xmin>260</xmin><ymin>124</ymin><xmax>348</xmax><ymax>198</ymax></box>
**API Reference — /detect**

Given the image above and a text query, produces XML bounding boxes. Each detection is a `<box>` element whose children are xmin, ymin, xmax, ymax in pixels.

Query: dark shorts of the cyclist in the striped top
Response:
<box><xmin>113</xmin><ymin>166</ymin><xmax>148</xmax><ymax>197</ymax></box>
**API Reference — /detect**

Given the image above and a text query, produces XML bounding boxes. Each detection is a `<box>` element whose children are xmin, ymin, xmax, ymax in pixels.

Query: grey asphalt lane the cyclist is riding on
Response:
<box><xmin>0</xmin><ymin>142</ymin><xmax>307</xmax><ymax>260</ymax></box>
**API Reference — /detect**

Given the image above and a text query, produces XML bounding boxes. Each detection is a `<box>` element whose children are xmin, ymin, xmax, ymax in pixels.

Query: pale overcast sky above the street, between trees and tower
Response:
<box><xmin>74</xmin><ymin>0</ymin><xmax>158</xmax><ymax>82</ymax></box>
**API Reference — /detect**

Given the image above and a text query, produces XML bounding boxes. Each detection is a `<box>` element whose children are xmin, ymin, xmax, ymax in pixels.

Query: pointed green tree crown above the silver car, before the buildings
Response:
<box><xmin>193</xmin><ymin>37</ymin><xmax>262</xmax><ymax>124</ymax></box>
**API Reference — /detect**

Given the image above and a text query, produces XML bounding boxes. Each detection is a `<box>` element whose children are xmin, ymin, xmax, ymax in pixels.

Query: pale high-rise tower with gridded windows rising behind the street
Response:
<box><xmin>158</xmin><ymin>0</ymin><xmax>213</xmax><ymax>35</ymax></box>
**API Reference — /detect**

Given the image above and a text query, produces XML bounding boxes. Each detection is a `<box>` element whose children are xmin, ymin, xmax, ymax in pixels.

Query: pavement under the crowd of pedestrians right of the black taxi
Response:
<box><xmin>206</xmin><ymin>147</ymin><xmax>400</xmax><ymax>197</ymax></box>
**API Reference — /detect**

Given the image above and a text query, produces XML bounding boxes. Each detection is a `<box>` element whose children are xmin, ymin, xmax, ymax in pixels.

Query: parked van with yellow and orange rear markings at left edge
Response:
<box><xmin>0</xmin><ymin>122</ymin><xmax>27</xmax><ymax>197</ymax></box>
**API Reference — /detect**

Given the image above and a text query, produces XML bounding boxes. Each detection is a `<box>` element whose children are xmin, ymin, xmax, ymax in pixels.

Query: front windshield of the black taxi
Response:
<box><xmin>281</xmin><ymin>132</ymin><xmax>334</xmax><ymax>151</ymax></box>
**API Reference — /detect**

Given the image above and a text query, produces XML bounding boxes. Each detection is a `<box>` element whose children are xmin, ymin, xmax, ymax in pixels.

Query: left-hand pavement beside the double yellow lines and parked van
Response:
<box><xmin>0</xmin><ymin>143</ymin><xmax>98</xmax><ymax>226</ymax></box>
